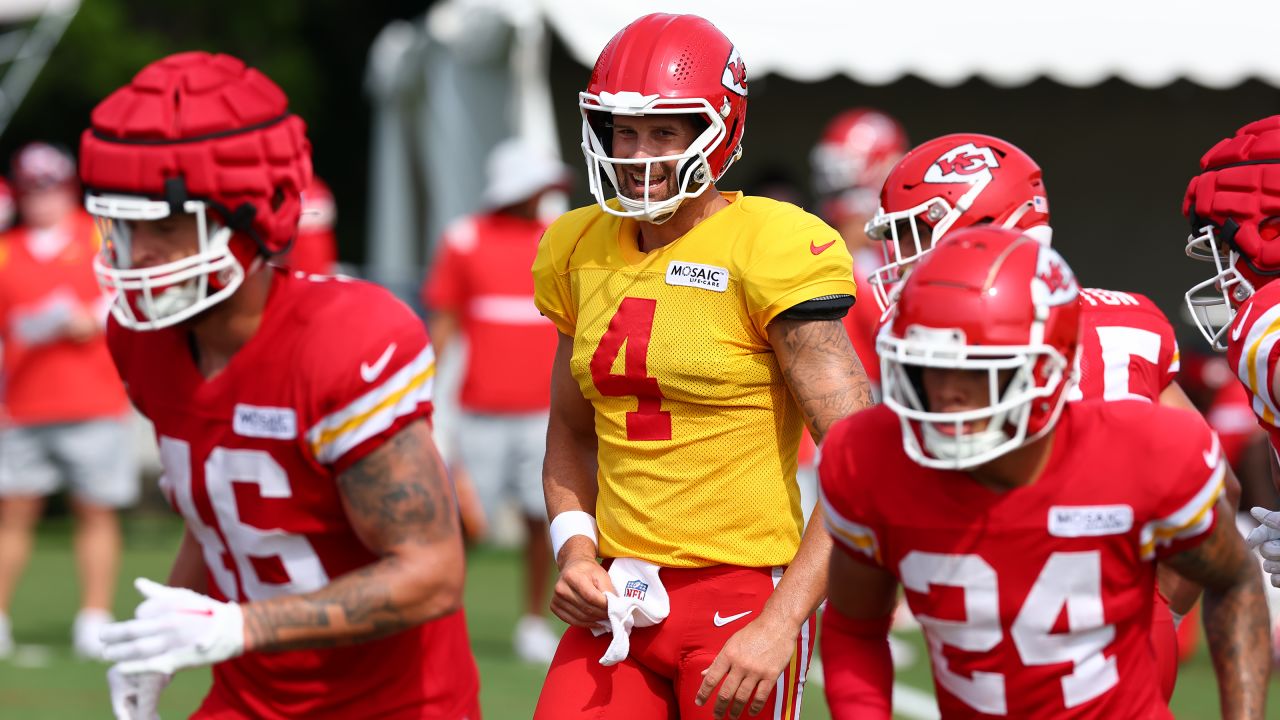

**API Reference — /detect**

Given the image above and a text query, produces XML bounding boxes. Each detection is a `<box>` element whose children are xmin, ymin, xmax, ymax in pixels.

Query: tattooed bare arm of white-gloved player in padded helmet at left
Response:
<box><xmin>243</xmin><ymin>421</ymin><xmax>461</xmax><ymax>651</ymax></box>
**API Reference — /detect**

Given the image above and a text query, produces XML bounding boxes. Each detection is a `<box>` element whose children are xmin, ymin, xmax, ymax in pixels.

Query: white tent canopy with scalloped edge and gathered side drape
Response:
<box><xmin>368</xmin><ymin>0</ymin><xmax>1280</xmax><ymax>287</ymax></box>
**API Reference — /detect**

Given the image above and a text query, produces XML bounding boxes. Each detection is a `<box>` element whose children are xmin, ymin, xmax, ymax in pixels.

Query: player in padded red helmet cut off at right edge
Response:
<box><xmin>1183</xmin><ymin>115</ymin><xmax>1280</xmax><ymax>594</ymax></box>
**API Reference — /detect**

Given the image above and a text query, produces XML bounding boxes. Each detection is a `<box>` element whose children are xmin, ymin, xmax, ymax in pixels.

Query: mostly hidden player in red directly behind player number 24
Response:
<box><xmin>868</xmin><ymin>133</ymin><xmax>1240</xmax><ymax>697</ymax></box>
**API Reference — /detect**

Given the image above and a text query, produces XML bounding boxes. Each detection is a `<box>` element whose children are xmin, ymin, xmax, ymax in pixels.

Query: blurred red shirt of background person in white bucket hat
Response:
<box><xmin>422</xmin><ymin>213</ymin><xmax>557</xmax><ymax>413</ymax></box>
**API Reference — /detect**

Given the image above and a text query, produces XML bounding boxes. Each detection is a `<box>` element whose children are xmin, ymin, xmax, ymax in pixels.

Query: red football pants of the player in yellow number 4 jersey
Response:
<box><xmin>534</xmin><ymin>565</ymin><xmax>814</xmax><ymax>720</ymax></box>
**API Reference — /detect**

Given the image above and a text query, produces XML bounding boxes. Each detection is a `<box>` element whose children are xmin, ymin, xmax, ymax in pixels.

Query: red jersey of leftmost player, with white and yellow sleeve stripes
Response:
<box><xmin>108</xmin><ymin>269</ymin><xmax>479</xmax><ymax>720</ymax></box>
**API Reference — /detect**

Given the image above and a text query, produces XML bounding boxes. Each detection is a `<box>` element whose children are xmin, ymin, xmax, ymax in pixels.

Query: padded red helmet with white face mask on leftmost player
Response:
<box><xmin>81</xmin><ymin>53</ymin><xmax>311</xmax><ymax>329</ymax></box>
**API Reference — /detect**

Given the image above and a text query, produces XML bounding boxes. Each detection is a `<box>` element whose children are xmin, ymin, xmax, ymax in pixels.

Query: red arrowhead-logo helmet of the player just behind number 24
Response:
<box><xmin>867</xmin><ymin>133</ymin><xmax>1050</xmax><ymax>309</ymax></box>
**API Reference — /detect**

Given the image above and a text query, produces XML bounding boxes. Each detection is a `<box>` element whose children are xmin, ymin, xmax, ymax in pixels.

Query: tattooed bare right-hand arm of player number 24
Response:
<box><xmin>1169</xmin><ymin>503</ymin><xmax>1271</xmax><ymax>719</ymax></box>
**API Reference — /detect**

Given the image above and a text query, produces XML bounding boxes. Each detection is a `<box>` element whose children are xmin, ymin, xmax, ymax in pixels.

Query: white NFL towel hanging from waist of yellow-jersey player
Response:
<box><xmin>591</xmin><ymin>557</ymin><xmax>671</xmax><ymax>666</ymax></box>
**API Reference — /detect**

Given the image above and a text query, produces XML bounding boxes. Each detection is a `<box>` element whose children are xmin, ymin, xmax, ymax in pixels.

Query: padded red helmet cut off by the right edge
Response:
<box><xmin>1183</xmin><ymin>115</ymin><xmax>1280</xmax><ymax>351</ymax></box>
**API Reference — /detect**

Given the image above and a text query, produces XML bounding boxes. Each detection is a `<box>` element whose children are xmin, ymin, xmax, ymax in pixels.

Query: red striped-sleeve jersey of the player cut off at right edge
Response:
<box><xmin>1226</xmin><ymin>282</ymin><xmax>1280</xmax><ymax>454</ymax></box>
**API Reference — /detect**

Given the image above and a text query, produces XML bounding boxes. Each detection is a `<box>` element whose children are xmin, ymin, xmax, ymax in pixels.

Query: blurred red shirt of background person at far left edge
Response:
<box><xmin>0</xmin><ymin>211</ymin><xmax>128</xmax><ymax>425</ymax></box>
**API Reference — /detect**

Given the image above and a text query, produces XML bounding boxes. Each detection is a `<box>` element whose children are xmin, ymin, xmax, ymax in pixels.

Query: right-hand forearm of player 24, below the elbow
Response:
<box><xmin>1204</xmin><ymin>557</ymin><xmax>1271</xmax><ymax>720</ymax></box>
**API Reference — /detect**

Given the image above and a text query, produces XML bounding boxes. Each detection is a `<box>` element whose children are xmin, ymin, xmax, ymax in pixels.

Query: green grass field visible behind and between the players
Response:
<box><xmin>0</xmin><ymin>515</ymin><xmax>1280</xmax><ymax>720</ymax></box>
